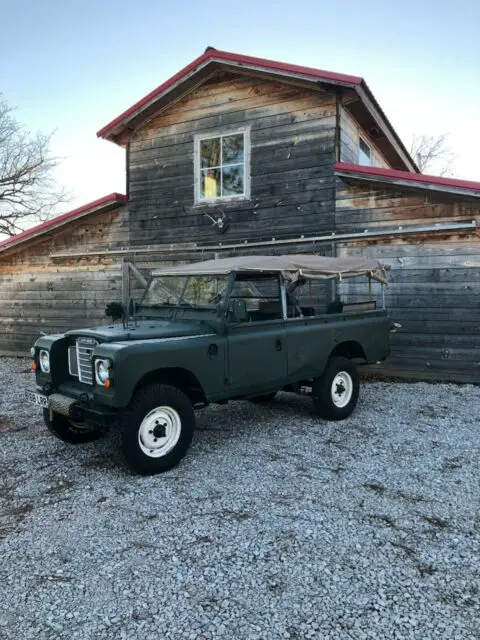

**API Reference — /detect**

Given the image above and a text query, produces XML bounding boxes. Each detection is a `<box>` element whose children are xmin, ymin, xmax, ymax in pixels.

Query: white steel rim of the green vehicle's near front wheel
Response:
<box><xmin>138</xmin><ymin>407</ymin><xmax>182</xmax><ymax>458</ymax></box>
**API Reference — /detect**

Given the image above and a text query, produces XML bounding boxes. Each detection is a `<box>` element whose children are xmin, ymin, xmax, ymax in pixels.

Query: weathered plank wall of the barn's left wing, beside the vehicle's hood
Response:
<box><xmin>0</xmin><ymin>207</ymin><xmax>128</xmax><ymax>355</ymax></box>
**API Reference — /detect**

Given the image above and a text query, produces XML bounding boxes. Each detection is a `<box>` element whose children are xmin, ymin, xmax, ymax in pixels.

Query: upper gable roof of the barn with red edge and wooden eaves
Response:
<box><xmin>97</xmin><ymin>47</ymin><xmax>418</xmax><ymax>171</ymax></box>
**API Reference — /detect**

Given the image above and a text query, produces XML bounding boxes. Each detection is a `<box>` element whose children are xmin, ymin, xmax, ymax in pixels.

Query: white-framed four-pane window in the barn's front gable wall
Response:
<box><xmin>195</xmin><ymin>130</ymin><xmax>250</xmax><ymax>203</ymax></box>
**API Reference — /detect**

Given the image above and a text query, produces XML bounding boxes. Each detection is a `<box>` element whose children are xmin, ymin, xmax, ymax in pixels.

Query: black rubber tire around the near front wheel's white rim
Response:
<box><xmin>119</xmin><ymin>384</ymin><xmax>195</xmax><ymax>475</ymax></box>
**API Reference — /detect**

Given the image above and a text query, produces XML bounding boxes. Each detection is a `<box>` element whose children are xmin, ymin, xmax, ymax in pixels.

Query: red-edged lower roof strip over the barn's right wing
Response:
<box><xmin>335</xmin><ymin>162</ymin><xmax>480</xmax><ymax>198</ymax></box>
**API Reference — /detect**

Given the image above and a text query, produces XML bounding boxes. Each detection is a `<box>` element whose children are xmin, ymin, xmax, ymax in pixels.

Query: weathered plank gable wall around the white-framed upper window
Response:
<box><xmin>129</xmin><ymin>74</ymin><xmax>336</xmax><ymax>245</ymax></box>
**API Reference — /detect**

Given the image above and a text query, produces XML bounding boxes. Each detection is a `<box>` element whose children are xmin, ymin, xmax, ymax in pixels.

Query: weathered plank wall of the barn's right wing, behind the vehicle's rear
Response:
<box><xmin>336</xmin><ymin>180</ymin><xmax>480</xmax><ymax>382</ymax></box>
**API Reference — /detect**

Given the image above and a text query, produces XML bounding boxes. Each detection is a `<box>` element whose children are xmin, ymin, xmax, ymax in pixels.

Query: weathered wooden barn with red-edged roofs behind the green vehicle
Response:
<box><xmin>0</xmin><ymin>48</ymin><xmax>480</xmax><ymax>382</ymax></box>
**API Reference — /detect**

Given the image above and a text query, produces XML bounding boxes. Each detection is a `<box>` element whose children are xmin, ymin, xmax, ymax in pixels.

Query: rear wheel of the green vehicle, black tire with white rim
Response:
<box><xmin>312</xmin><ymin>356</ymin><xmax>360</xmax><ymax>420</ymax></box>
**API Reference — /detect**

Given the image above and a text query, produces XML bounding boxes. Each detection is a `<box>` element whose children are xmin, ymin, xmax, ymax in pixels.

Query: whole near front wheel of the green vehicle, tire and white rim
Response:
<box><xmin>120</xmin><ymin>384</ymin><xmax>195</xmax><ymax>475</ymax></box>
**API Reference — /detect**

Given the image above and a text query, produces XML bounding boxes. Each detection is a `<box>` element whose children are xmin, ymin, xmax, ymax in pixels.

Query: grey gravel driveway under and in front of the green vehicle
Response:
<box><xmin>0</xmin><ymin>358</ymin><xmax>480</xmax><ymax>640</ymax></box>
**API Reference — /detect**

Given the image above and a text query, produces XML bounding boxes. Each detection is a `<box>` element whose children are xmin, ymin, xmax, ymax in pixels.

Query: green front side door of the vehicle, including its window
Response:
<box><xmin>227</xmin><ymin>273</ymin><xmax>287</xmax><ymax>395</ymax></box>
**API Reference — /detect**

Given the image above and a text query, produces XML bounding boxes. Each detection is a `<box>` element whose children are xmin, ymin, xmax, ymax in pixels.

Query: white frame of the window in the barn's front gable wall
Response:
<box><xmin>193</xmin><ymin>127</ymin><xmax>251</xmax><ymax>205</ymax></box>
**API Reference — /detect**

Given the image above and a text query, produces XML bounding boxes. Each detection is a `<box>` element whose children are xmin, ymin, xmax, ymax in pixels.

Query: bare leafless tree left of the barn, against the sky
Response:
<box><xmin>0</xmin><ymin>94</ymin><xmax>67</xmax><ymax>236</ymax></box>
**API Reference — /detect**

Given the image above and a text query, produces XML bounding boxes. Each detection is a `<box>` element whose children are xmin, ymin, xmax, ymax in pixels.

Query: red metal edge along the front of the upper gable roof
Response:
<box><xmin>97</xmin><ymin>48</ymin><xmax>362</xmax><ymax>138</ymax></box>
